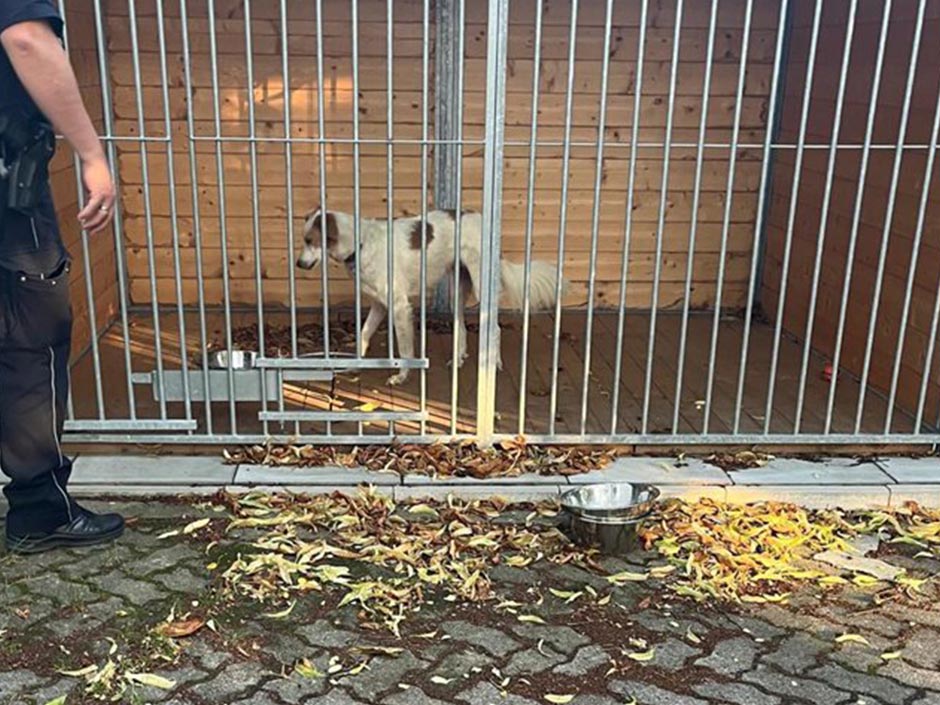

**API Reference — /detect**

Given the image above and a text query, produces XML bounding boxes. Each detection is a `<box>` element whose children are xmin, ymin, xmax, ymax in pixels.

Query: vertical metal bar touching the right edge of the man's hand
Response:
<box><xmin>94</xmin><ymin>0</ymin><xmax>137</xmax><ymax>421</ymax></box>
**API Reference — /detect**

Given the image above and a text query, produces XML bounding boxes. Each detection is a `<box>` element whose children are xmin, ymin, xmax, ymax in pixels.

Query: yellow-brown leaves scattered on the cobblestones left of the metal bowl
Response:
<box><xmin>222</xmin><ymin>490</ymin><xmax>591</xmax><ymax>634</ymax></box>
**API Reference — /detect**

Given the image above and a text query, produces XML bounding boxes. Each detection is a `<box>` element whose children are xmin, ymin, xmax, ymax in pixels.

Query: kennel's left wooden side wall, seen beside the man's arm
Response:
<box><xmin>50</xmin><ymin>2</ymin><xmax>118</xmax><ymax>356</ymax></box>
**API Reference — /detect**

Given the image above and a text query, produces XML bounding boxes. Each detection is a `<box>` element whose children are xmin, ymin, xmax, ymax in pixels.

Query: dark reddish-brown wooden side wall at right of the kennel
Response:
<box><xmin>761</xmin><ymin>0</ymin><xmax>940</xmax><ymax>422</ymax></box>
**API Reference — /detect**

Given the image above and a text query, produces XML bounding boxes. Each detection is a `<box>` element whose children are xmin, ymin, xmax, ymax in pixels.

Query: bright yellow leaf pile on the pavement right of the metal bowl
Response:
<box><xmin>641</xmin><ymin>499</ymin><xmax>940</xmax><ymax>603</ymax></box>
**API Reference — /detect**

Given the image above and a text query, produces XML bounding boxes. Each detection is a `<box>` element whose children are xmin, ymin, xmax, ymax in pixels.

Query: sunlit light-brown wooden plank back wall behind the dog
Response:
<box><xmin>107</xmin><ymin>0</ymin><xmax>778</xmax><ymax>308</ymax></box>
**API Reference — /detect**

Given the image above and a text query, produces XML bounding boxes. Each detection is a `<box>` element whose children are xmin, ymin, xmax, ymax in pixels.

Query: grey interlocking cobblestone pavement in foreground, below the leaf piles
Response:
<box><xmin>0</xmin><ymin>502</ymin><xmax>940</xmax><ymax>705</ymax></box>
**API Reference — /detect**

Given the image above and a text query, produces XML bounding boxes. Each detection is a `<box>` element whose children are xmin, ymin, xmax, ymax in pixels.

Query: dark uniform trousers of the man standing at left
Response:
<box><xmin>0</xmin><ymin>187</ymin><xmax>76</xmax><ymax>537</ymax></box>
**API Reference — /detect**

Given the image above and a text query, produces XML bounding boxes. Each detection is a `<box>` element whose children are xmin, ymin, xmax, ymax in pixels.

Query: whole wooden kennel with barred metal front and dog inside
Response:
<box><xmin>53</xmin><ymin>0</ymin><xmax>940</xmax><ymax>445</ymax></box>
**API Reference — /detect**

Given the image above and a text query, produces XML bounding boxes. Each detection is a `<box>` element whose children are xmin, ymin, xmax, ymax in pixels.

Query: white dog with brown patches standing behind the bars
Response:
<box><xmin>297</xmin><ymin>208</ymin><xmax>557</xmax><ymax>384</ymax></box>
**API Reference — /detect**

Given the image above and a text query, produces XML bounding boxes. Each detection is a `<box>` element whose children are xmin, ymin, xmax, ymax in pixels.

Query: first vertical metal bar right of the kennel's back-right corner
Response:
<box><xmin>764</xmin><ymin>0</ymin><xmax>823</xmax><ymax>434</ymax></box>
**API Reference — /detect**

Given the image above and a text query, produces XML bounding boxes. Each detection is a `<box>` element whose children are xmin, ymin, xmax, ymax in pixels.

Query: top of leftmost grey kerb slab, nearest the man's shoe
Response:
<box><xmin>69</xmin><ymin>455</ymin><xmax>235</xmax><ymax>484</ymax></box>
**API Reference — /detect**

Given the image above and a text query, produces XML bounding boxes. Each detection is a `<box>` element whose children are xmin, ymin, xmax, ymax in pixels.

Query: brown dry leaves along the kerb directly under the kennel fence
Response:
<box><xmin>224</xmin><ymin>439</ymin><xmax>618</xmax><ymax>479</ymax></box>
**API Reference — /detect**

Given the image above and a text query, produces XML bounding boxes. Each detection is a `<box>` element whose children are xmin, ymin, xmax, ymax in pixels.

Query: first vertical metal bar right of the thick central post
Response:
<box><xmin>519</xmin><ymin>2</ymin><xmax>542</xmax><ymax>435</ymax></box>
